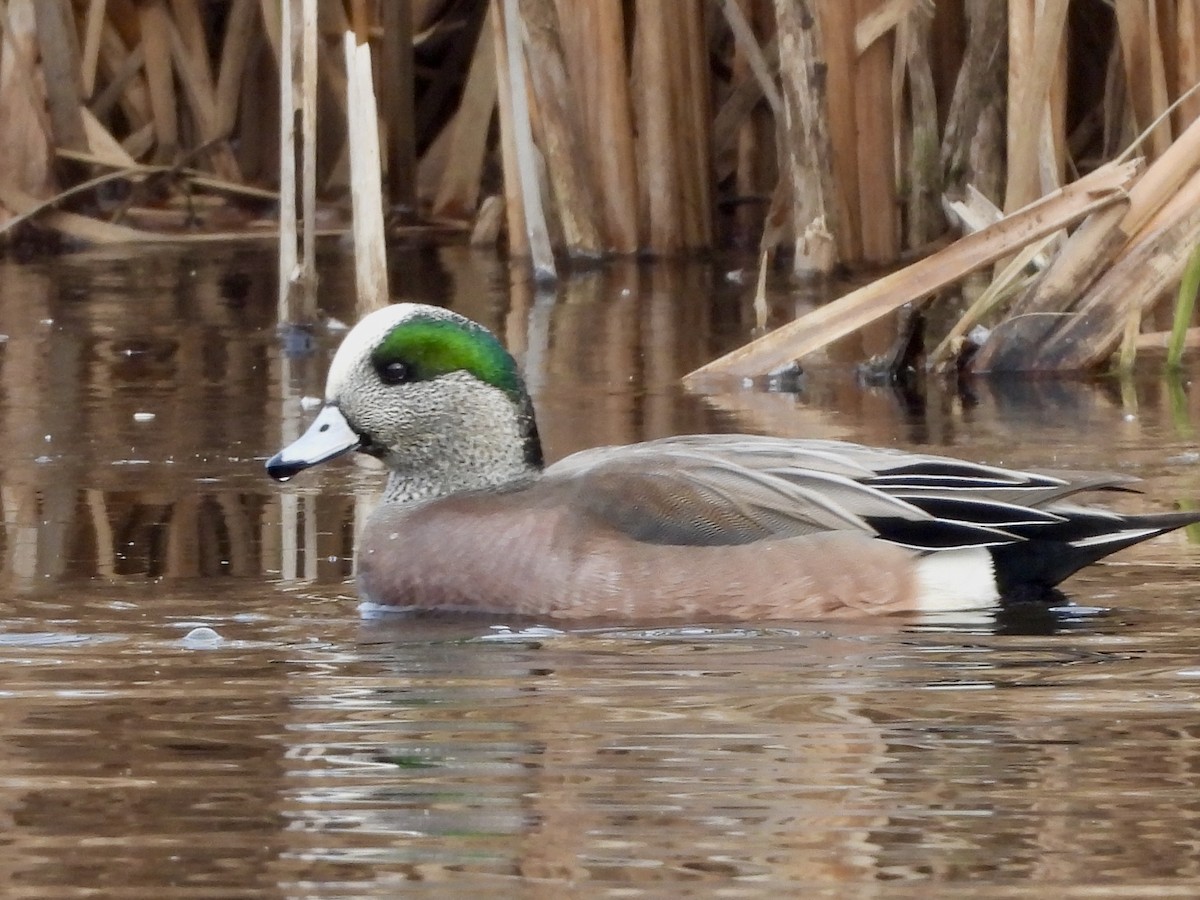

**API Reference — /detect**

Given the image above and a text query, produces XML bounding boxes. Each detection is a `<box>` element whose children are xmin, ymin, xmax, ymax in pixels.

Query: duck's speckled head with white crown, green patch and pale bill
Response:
<box><xmin>266</xmin><ymin>304</ymin><xmax>542</xmax><ymax>499</ymax></box>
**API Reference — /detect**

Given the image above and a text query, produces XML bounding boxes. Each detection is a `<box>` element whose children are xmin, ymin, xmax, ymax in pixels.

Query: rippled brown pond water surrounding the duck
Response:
<box><xmin>0</xmin><ymin>247</ymin><xmax>1200</xmax><ymax>898</ymax></box>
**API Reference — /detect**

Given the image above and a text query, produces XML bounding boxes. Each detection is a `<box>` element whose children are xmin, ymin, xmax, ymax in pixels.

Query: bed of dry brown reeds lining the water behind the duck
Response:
<box><xmin>0</xmin><ymin>0</ymin><xmax>1200</xmax><ymax>379</ymax></box>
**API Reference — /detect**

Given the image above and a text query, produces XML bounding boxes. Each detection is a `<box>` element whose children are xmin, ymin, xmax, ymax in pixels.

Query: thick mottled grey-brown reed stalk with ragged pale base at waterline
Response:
<box><xmin>775</xmin><ymin>0</ymin><xmax>841</xmax><ymax>276</ymax></box>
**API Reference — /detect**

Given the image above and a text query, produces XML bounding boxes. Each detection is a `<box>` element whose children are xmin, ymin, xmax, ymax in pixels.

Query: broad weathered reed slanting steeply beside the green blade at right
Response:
<box><xmin>1031</xmin><ymin>168</ymin><xmax>1200</xmax><ymax>372</ymax></box>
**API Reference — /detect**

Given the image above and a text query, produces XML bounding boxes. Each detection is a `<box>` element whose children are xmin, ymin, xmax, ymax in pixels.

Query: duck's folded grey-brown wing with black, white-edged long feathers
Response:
<box><xmin>544</xmin><ymin>434</ymin><xmax>1132</xmax><ymax>546</ymax></box>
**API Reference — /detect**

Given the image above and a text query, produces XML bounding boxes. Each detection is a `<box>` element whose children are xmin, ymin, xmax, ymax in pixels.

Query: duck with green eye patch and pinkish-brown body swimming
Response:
<box><xmin>266</xmin><ymin>302</ymin><xmax>1200</xmax><ymax>622</ymax></box>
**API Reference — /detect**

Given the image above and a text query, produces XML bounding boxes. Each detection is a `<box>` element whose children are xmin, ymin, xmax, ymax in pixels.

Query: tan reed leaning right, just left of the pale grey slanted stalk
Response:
<box><xmin>432</xmin><ymin>10</ymin><xmax>496</xmax><ymax>218</ymax></box>
